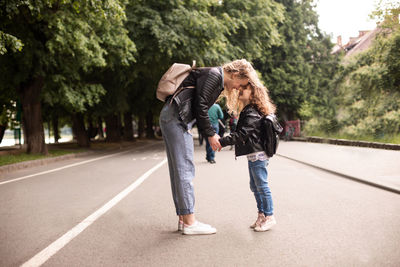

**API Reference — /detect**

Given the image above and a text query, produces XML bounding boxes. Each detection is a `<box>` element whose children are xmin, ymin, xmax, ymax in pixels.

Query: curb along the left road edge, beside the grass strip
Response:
<box><xmin>0</xmin><ymin>151</ymin><xmax>94</xmax><ymax>175</ymax></box>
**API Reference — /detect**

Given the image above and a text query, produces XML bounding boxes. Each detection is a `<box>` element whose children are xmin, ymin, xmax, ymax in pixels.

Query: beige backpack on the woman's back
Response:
<box><xmin>156</xmin><ymin>60</ymin><xmax>196</xmax><ymax>102</ymax></box>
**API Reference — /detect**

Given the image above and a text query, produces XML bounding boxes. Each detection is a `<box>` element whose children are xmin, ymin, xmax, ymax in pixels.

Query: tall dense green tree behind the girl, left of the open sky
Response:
<box><xmin>256</xmin><ymin>0</ymin><xmax>338</xmax><ymax>120</ymax></box>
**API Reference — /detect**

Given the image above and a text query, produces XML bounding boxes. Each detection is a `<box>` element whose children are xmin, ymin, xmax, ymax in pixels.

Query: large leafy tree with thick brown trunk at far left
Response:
<box><xmin>0</xmin><ymin>0</ymin><xmax>135</xmax><ymax>153</ymax></box>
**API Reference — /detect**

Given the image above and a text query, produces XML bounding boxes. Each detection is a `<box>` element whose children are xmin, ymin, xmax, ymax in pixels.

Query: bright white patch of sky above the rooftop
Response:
<box><xmin>315</xmin><ymin>0</ymin><xmax>377</xmax><ymax>44</ymax></box>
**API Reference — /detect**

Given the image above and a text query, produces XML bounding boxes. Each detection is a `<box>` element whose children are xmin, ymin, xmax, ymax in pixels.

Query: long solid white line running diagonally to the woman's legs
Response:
<box><xmin>21</xmin><ymin>158</ymin><xmax>167</xmax><ymax>267</ymax></box>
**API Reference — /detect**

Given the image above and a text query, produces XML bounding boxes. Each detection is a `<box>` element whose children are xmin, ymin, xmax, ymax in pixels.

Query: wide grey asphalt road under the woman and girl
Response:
<box><xmin>0</xmin><ymin>142</ymin><xmax>400</xmax><ymax>266</ymax></box>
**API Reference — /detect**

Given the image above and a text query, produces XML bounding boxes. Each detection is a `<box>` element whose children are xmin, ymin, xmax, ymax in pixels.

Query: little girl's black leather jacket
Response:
<box><xmin>219</xmin><ymin>105</ymin><xmax>265</xmax><ymax>157</ymax></box>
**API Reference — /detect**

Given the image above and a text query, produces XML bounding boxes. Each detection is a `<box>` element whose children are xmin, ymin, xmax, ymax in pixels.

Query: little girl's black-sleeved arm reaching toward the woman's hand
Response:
<box><xmin>219</xmin><ymin>113</ymin><xmax>260</xmax><ymax>147</ymax></box>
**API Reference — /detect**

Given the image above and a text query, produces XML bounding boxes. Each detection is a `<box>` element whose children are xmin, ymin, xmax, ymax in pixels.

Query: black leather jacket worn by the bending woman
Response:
<box><xmin>173</xmin><ymin>67</ymin><xmax>224</xmax><ymax>137</ymax></box>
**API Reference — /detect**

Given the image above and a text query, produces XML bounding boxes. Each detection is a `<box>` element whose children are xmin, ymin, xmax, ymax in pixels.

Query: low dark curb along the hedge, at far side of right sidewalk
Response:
<box><xmin>291</xmin><ymin>136</ymin><xmax>400</xmax><ymax>150</ymax></box>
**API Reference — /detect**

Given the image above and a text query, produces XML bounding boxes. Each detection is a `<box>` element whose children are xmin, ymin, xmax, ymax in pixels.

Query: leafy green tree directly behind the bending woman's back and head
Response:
<box><xmin>126</xmin><ymin>0</ymin><xmax>283</xmax><ymax>136</ymax></box>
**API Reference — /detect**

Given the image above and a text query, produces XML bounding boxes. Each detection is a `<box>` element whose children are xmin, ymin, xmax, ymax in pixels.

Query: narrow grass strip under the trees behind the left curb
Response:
<box><xmin>0</xmin><ymin>149</ymin><xmax>85</xmax><ymax>166</ymax></box>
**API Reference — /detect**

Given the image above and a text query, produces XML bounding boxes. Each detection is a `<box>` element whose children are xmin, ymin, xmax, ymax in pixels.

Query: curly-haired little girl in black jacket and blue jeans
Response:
<box><xmin>219</xmin><ymin>75</ymin><xmax>276</xmax><ymax>232</ymax></box>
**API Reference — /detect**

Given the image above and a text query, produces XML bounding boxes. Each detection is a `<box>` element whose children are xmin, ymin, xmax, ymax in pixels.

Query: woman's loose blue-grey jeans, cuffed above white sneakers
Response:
<box><xmin>160</xmin><ymin>102</ymin><xmax>195</xmax><ymax>215</ymax></box>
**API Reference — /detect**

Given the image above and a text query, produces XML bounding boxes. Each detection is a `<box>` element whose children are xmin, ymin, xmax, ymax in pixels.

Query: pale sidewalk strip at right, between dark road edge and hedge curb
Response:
<box><xmin>278</xmin><ymin>141</ymin><xmax>400</xmax><ymax>195</ymax></box>
